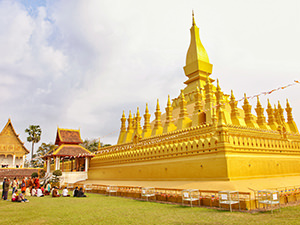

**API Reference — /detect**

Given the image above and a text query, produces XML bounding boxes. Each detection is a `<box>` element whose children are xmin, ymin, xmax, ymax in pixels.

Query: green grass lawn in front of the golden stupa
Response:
<box><xmin>0</xmin><ymin>194</ymin><xmax>300</xmax><ymax>224</ymax></box>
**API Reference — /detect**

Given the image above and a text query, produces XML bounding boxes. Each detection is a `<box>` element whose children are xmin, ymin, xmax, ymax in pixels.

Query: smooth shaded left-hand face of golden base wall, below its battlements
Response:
<box><xmin>88</xmin><ymin>153</ymin><xmax>228</xmax><ymax>180</ymax></box>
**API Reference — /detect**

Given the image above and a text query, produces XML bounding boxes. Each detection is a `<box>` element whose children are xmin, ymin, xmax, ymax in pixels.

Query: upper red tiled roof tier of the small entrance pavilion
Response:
<box><xmin>55</xmin><ymin>128</ymin><xmax>82</xmax><ymax>145</ymax></box>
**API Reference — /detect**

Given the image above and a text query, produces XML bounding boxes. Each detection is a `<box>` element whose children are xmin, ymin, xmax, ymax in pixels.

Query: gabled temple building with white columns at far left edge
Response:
<box><xmin>0</xmin><ymin>119</ymin><xmax>29</xmax><ymax>168</ymax></box>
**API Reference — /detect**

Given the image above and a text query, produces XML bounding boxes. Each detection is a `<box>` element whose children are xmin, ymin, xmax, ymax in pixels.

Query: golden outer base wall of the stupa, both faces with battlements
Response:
<box><xmin>88</xmin><ymin>125</ymin><xmax>300</xmax><ymax>180</ymax></box>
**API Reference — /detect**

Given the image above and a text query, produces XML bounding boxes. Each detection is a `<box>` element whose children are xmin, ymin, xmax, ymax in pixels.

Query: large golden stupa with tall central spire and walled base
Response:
<box><xmin>88</xmin><ymin>16</ymin><xmax>300</xmax><ymax>181</ymax></box>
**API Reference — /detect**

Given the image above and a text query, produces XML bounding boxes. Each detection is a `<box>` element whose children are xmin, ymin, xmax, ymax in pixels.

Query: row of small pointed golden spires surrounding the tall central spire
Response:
<box><xmin>118</xmin><ymin>79</ymin><xmax>298</xmax><ymax>144</ymax></box>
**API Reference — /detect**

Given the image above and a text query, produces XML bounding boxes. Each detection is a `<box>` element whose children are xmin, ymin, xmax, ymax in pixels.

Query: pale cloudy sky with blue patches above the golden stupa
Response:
<box><xmin>0</xmin><ymin>0</ymin><xmax>300</xmax><ymax>158</ymax></box>
